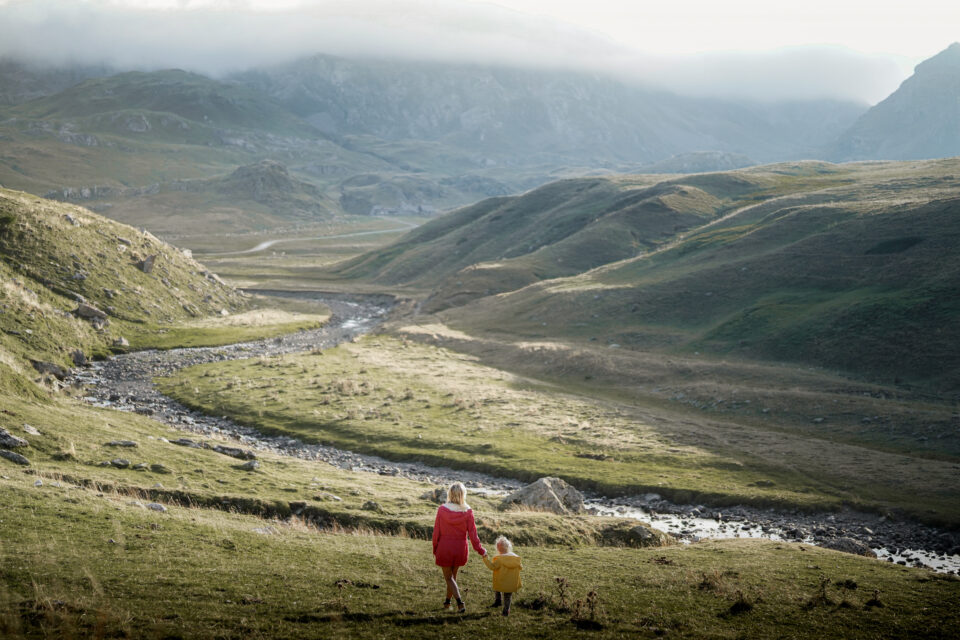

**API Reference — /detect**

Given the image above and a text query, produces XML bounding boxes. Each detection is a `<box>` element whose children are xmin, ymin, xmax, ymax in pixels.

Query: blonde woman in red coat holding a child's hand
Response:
<box><xmin>433</xmin><ymin>482</ymin><xmax>487</xmax><ymax>613</ymax></box>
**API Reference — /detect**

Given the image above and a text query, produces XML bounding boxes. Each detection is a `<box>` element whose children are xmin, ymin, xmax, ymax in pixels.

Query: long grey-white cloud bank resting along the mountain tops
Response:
<box><xmin>0</xmin><ymin>0</ymin><xmax>909</xmax><ymax>102</ymax></box>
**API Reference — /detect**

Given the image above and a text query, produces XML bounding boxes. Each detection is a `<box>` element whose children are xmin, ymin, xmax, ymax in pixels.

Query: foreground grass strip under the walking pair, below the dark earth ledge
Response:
<box><xmin>0</xmin><ymin>473</ymin><xmax>960</xmax><ymax>638</ymax></box>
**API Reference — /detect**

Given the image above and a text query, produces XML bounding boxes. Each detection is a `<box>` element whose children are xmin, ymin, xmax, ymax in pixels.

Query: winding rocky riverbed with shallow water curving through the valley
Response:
<box><xmin>73</xmin><ymin>293</ymin><xmax>960</xmax><ymax>573</ymax></box>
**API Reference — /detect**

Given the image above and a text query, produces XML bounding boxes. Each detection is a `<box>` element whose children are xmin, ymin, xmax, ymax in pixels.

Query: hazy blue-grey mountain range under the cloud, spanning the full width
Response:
<box><xmin>0</xmin><ymin>45</ymin><xmax>960</xmax><ymax>236</ymax></box>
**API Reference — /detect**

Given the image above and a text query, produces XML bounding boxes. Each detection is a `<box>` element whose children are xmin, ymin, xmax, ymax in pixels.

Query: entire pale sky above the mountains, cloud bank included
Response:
<box><xmin>0</xmin><ymin>0</ymin><xmax>960</xmax><ymax>103</ymax></box>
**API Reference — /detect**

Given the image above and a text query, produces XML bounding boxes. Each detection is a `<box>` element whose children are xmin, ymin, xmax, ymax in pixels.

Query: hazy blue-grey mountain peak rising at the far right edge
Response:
<box><xmin>831</xmin><ymin>42</ymin><xmax>960</xmax><ymax>160</ymax></box>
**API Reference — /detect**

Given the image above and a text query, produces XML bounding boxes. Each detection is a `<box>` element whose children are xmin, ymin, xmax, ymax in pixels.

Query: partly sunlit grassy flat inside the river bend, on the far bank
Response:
<box><xmin>157</xmin><ymin>336</ymin><xmax>960</xmax><ymax>522</ymax></box>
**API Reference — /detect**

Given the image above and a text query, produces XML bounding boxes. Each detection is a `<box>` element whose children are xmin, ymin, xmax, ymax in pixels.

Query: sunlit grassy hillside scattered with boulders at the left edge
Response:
<box><xmin>0</xmin><ymin>189</ymin><xmax>245</xmax><ymax>391</ymax></box>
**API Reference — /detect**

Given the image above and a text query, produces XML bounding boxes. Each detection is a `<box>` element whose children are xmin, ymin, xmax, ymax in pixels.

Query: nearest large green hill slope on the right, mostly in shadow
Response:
<box><xmin>434</xmin><ymin>160</ymin><xmax>960</xmax><ymax>394</ymax></box>
